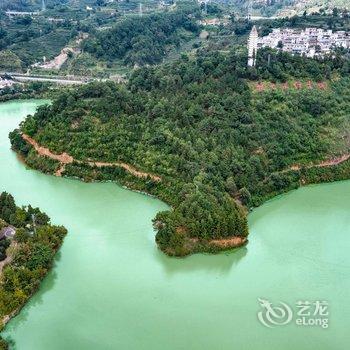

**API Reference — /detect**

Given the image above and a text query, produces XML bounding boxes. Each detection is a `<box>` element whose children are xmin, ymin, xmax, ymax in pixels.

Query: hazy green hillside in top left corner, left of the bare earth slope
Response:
<box><xmin>0</xmin><ymin>1</ymin><xmax>127</xmax><ymax>71</ymax></box>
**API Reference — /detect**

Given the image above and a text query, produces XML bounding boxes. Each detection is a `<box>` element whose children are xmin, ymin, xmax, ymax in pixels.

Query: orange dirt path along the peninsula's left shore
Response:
<box><xmin>22</xmin><ymin>134</ymin><xmax>162</xmax><ymax>182</ymax></box>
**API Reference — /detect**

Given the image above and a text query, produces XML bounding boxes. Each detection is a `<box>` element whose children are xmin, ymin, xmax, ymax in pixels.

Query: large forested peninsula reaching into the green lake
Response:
<box><xmin>10</xmin><ymin>49</ymin><xmax>350</xmax><ymax>256</ymax></box>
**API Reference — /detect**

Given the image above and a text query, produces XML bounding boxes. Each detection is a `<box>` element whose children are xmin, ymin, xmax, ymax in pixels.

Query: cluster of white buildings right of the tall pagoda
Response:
<box><xmin>257</xmin><ymin>28</ymin><xmax>350</xmax><ymax>58</ymax></box>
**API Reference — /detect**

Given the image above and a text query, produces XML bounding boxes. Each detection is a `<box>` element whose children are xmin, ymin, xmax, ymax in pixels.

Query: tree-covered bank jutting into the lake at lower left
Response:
<box><xmin>0</xmin><ymin>192</ymin><xmax>67</xmax><ymax>349</ymax></box>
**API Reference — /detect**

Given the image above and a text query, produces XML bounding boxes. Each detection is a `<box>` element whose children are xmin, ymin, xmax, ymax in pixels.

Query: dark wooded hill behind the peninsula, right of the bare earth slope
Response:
<box><xmin>83</xmin><ymin>7</ymin><xmax>199</xmax><ymax>66</ymax></box>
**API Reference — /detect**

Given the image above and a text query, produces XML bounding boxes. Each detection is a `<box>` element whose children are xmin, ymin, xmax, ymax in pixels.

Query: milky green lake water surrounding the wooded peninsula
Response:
<box><xmin>0</xmin><ymin>101</ymin><xmax>350</xmax><ymax>350</ymax></box>
